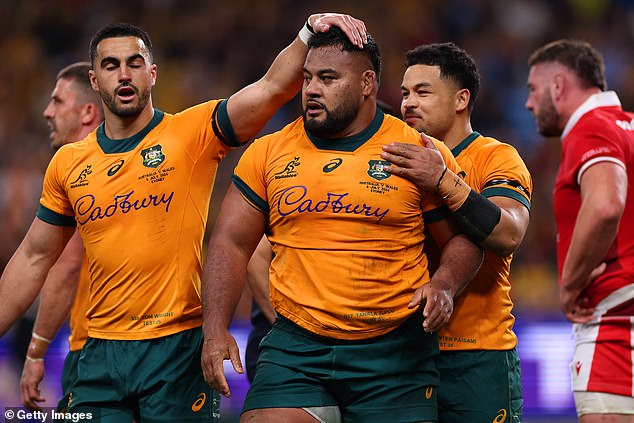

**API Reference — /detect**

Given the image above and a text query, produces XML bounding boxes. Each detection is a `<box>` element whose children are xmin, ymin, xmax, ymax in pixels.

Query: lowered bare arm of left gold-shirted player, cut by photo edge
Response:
<box><xmin>0</xmin><ymin>218</ymin><xmax>75</xmax><ymax>335</ymax></box>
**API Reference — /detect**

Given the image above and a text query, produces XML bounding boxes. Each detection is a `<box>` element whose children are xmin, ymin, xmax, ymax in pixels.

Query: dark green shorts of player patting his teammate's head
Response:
<box><xmin>68</xmin><ymin>327</ymin><xmax>220</xmax><ymax>423</ymax></box>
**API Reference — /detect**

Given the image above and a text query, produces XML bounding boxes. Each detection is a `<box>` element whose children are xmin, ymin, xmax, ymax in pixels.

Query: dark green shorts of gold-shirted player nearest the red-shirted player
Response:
<box><xmin>438</xmin><ymin>348</ymin><xmax>523</xmax><ymax>423</ymax></box>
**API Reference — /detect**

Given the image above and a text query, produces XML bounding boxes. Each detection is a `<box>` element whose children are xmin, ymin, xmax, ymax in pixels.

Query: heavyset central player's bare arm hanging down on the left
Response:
<box><xmin>201</xmin><ymin>184</ymin><xmax>266</xmax><ymax>397</ymax></box>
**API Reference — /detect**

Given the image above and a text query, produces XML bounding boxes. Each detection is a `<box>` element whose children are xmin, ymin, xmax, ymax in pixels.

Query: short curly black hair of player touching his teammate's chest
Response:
<box><xmin>405</xmin><ymin>43</ymin><xmax>480</xmax><ymax>114</ymax></box>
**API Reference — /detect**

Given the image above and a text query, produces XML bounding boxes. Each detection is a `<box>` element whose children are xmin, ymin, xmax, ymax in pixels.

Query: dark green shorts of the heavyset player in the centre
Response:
<box><xmin>243</xmin><ymin>313</ymin><xmax>439</xmax><ymax>423</ymax></box>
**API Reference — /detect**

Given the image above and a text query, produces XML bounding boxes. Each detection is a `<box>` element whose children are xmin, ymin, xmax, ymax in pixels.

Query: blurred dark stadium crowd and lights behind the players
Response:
<box><xmin>0</xmin><ymin>0</ymin><xmax>634</xmax><ymax>422</ymax></box>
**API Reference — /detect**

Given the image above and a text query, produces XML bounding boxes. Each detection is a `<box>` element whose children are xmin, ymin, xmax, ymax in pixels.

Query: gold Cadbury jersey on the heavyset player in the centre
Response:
<box><xmin>233</xmin><ymin>110</ymin><xmax>460</xmax><ymax>339</ymax></box>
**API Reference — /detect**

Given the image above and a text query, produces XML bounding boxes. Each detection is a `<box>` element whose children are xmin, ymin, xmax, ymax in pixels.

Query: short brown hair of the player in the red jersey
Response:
<box><xmin>528</xmin><ymin>39</ymin><xmax>608</xmax><ymax>91</ymax></box>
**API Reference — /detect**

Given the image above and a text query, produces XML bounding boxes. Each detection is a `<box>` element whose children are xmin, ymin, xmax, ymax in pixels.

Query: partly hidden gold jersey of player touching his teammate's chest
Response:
<box><xmin>438</xmin><ymin>132</ymin><xmax>533</xmax><ymax>350</ymax></box>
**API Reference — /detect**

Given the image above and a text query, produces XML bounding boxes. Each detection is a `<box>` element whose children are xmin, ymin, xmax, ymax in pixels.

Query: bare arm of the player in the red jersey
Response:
<box><xmin>559</xmin><ymin>162</ymin><xmax>629</xmax><ymax>322</ymax></box>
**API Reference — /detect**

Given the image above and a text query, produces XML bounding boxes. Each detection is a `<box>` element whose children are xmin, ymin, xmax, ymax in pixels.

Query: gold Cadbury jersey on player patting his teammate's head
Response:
<box><xmin>38</xmin><ymin>100</ymin><xmax>238</xmax><ymax>340</ymax></box>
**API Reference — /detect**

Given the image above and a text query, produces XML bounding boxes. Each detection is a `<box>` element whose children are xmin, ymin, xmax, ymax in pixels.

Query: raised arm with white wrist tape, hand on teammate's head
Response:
<box><xmin>227</xmin><ymin>13</ymin><xmax>367</xmax><ymax>142</ymax></box>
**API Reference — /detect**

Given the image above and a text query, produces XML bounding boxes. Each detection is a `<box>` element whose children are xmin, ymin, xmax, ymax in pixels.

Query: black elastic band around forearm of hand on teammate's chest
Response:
<box><xmin>453</xmin><ymin>189</ymin><xmax>502</xmax><ymax>243</ymax></box>
